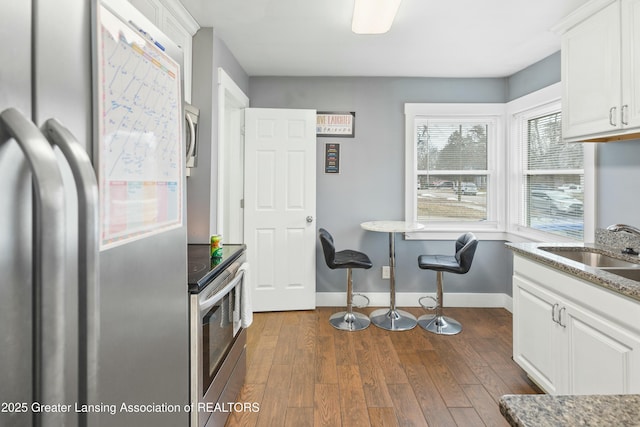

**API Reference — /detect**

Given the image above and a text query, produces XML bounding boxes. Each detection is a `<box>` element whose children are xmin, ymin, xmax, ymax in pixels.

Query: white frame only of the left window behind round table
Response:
<box><xmin>404</xmin><ymin>103</ymin><xmax>506</xmax><ymax>240</ymax></box>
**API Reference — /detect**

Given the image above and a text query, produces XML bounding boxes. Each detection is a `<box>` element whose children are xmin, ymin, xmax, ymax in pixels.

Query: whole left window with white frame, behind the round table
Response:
<box><xmin>405</xmin><ymin>104</ymin><xmax>504</xmax><ymax>237</ymax></box>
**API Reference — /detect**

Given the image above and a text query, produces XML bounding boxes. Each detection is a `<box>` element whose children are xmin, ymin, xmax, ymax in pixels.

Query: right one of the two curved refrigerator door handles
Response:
<box><xmin>42</xmin><ymin>119</ymin><xmax>100</xmax><ymax>425</ymax></box>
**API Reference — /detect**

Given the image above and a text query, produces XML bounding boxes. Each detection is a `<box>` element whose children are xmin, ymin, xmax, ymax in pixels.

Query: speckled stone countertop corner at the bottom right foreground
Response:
<box><xmin>500</xmin><ymin>394</ymin><xmax>640</xmax><ymax>427</ymax></box>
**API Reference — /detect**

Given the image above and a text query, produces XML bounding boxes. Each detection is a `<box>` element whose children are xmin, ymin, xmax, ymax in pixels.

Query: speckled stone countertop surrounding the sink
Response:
<box><xmin>506</xmin><ymin>243</ymin><xmax>640</xmax><ymax>301</ymax></box>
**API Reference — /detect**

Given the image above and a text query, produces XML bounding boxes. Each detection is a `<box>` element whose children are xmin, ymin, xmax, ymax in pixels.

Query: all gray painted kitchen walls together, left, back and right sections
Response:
<box><xmin>188</xmin><ymin>41</ymin><xmax>640</xmax><ymax>295</ymax></box>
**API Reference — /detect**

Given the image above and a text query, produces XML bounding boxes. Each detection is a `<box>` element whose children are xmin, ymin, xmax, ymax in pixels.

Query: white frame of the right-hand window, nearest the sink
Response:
<box><xmin>506</xmin><ymin>83</ymin><xmax>595</xmax><ymax>243</ymax></box>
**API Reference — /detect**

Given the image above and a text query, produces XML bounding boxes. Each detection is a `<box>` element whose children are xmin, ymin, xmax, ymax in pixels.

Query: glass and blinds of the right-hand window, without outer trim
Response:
<box><xmin>519</xmin><ymin>109</ymin><xmax>584</xmax><ymax>240</ymax></box>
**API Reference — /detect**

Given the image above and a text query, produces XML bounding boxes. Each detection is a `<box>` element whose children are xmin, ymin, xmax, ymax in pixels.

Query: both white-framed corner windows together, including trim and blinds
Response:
<box><xmin>405</xmin><ymin>83</ymin><xmax>595</xmax><ymax>241</ymax></box>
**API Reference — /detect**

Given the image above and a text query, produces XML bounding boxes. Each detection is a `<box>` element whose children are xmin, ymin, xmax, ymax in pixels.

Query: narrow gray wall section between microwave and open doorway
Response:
<box><xmin>187</xmin><ymin>28</ymin><xmax>249</xmax><ymax>243</ymax></box>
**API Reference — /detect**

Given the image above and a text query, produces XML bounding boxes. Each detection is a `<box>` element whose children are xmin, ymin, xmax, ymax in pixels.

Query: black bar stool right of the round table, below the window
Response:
<box><xmin>418</xmin><ymin>233</ymin><xmax>478</xmax><ymax>335</ymax></box>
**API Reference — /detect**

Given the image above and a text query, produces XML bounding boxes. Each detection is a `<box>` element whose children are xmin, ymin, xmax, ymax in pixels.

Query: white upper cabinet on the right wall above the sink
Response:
<box><xmin>557</xmin><ymin>0</ymin><xmax>640</xmax><ymax>141</ymax></box>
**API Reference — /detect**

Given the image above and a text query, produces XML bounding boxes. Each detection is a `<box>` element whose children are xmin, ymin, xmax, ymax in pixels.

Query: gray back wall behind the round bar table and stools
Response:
<box><xmin>249</xmin><ymin>77</ymin><xmax>543</xmax><ymax>295</ymax></box>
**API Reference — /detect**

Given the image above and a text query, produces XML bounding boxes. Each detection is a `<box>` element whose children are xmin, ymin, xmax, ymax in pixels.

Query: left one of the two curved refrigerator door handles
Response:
<box><xmin>0</xmin><ymin>108</ymin><xmax>66</xmax><ymax>426</ymax></box>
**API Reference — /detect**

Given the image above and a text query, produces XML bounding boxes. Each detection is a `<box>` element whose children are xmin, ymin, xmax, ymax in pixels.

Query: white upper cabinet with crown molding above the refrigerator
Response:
<box><xmin>129</xmin><ymin>0</ymin><xmax>200</xmax><ymax>102</ymax></box>
